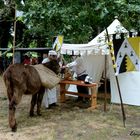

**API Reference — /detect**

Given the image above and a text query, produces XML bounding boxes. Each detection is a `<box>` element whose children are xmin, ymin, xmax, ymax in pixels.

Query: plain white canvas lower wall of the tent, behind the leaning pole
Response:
<box><xmin>110</xmin><ymin>71</ymin><xmax>140</xmax><ymax>106</ymax></box>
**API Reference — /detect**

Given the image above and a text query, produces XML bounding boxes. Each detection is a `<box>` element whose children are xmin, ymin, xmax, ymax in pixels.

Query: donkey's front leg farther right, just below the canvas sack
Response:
<box><xmin>37</xmin><ymin>87</ymin><xmax>45</xmax><ymax>116</ymax></box>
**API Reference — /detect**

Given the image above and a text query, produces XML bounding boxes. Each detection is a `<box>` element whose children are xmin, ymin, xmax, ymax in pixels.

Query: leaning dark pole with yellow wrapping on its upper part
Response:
<box><xmin>106</xmin><ymin>28</ymin><xmax>126</xmax><ymax>127</ymax></box>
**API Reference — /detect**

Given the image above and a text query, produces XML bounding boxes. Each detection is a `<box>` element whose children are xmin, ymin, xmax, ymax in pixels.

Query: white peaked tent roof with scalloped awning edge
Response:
<box><xmin>61</xmin><ymin>19</ymin><xmax>128</xmax><ymax>55</ymax></box>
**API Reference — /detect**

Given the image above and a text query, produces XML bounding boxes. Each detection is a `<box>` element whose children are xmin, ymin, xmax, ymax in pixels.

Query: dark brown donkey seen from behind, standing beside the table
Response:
<box><xmin>3</xmin><ymin>60</ymin><xmax>60</xmax><ymax>132</ymax></box>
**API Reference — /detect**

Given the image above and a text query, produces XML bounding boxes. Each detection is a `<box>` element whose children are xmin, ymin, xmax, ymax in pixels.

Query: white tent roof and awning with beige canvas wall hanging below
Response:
<box><xmin>61</xmin><ymin>19</ymin><xmax>128</xmax><ymax>82</ymax></box>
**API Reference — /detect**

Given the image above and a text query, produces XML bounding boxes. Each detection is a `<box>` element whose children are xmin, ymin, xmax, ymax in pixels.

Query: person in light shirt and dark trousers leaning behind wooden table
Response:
<box><xmin>65</xmin><ymin>57</ymin><xmax>88</xmax><ymax>101</ymax></box>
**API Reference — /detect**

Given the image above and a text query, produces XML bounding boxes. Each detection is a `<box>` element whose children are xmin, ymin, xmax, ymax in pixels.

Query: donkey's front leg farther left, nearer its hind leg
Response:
<box><xmin>30</xmin><ymin>93</ymin><xmax>37</xmax><ymax>117</ymax></box>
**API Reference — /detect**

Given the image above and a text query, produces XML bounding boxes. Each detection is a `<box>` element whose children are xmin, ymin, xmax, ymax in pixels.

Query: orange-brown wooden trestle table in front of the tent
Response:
<box><xmin>59</xmin><ymin>80</ymin><xmax>98</xmax><ymax>109</ymax></box>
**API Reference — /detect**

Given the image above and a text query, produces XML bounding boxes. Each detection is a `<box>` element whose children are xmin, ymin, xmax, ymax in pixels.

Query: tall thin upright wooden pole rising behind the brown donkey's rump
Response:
<box><xmin>13</xmin><ymin>4</ymin><xmax>16</xmax><ymax>64</ymax></box>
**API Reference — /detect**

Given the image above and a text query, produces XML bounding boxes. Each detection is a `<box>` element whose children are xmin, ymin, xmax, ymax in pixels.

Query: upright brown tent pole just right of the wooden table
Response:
<box><xmin>104</xmin><ymin>55</ymin><xmax>107</xmax><ymax>112</ymax></box>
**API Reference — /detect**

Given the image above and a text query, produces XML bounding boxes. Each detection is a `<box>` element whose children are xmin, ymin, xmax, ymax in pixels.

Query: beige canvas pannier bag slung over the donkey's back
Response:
<box><xmin>33</xmin><ymin>64</ymin><xmax>60</xmax><ymax>89</ymax></box>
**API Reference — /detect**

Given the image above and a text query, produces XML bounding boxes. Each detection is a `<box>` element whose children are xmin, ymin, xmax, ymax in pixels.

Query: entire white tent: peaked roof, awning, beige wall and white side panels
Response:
<box><xmin>61</xmin><ymin>19</ymin><xmax>140</xmax><ymax>106</ymax></box>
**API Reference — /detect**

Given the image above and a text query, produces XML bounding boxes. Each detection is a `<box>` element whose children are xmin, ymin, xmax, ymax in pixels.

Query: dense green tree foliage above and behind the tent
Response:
<box><xmin>0</xmin><ymin>0</ymin><xmax>140</xmax><ymax>47</ymax></box>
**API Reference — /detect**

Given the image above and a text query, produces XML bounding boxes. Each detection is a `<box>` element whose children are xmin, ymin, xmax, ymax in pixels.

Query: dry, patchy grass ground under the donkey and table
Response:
<box><xmin>0</xmin><ymin>76</ymin><xmax>140</xmax><ymax>140</ymax></box>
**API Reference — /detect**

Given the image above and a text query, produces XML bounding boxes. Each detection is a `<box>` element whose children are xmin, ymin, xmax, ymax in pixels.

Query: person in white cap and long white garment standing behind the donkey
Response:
<box><xmin>42</xmin><ymin>50</ymin><xmax>57</xmax><ymax>108</ymax></box>
